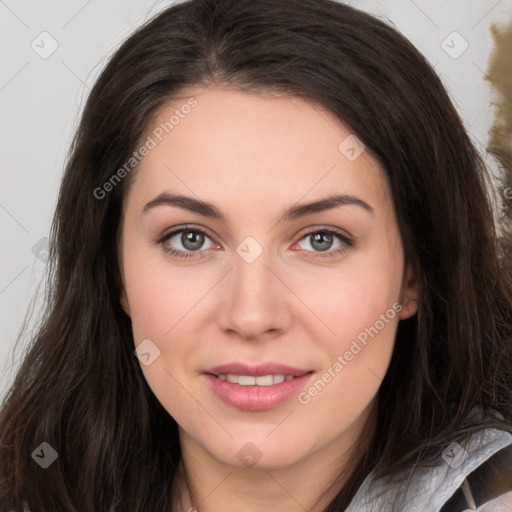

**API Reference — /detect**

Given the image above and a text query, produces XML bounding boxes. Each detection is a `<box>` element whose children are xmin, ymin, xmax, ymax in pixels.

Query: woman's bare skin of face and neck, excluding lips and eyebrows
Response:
<box><xmin>120</xmin><ymin>88</ymin><xmax>417</xmax><ymax>512</ymax></box>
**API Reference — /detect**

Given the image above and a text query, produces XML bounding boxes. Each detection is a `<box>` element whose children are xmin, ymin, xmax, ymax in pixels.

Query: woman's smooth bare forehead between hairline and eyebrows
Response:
<box><xmin>126</xmin><ymin>88</ymin><xmax>389</xmax><ymax>215</ymax></box>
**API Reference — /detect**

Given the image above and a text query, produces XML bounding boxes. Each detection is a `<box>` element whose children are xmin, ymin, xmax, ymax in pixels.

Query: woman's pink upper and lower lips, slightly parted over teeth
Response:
<box><xmin>202</xmin><ymin>363</ymin><xmax>315</xmax><ymax>411</ymax></box>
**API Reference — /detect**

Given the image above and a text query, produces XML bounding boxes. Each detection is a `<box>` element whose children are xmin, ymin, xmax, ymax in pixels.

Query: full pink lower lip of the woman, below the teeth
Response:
<box><xmin>203</xmin><ymin>372</ymin><xmax>313</xmax><ymax>411</ymax></box>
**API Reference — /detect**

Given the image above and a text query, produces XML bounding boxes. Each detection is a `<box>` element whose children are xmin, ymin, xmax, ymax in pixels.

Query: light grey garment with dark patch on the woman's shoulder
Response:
<box><xmin>347</xmin><ymin>428</ymin><xmax>512</xmax><ymax>512</ymax></box>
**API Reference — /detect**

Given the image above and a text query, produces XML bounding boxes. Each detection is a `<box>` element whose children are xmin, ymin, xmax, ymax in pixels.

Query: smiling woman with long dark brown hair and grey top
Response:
<box><xmin>0</xmin><ymin>0</ymin><xmax>512</xmax><ymax>512</ymax></box>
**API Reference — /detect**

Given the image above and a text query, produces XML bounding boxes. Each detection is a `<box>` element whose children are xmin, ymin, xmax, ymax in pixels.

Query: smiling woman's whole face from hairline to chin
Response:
<box><xmin>120</xmin><ymin>89</ymin><xmax>416</xmax><ymax>468</ymax></box>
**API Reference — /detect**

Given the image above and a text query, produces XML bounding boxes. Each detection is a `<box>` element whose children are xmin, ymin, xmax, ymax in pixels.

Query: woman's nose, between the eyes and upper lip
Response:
<box><xmin>218</xmin><ymin>246</ymin><xmax>293</xmax><ymax>340</ymax></box>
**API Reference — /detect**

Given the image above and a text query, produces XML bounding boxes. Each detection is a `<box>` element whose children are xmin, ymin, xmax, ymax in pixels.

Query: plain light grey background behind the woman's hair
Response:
<box><xmin>0</xmin><ymin>0</ymin><xmax>512</xmax><ymax>399</ymax></box>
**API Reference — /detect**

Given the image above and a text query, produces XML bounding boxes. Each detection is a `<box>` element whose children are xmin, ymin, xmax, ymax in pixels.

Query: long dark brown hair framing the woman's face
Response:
<box><xmin>0</xmin><ymin>0</ymin><xmax>512</xmax><ymax>512</ymax></box>
